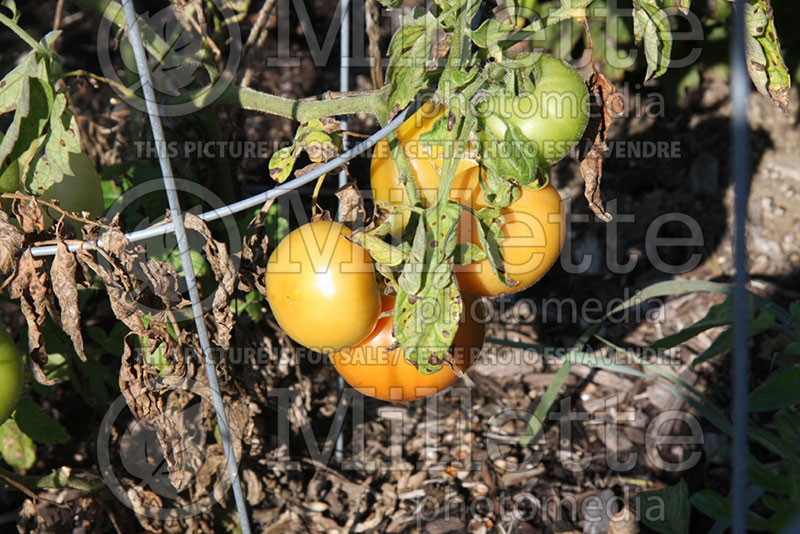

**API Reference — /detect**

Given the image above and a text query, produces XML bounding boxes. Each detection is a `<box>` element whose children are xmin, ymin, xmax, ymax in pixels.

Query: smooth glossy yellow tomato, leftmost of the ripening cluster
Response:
<box><xmin>264</xmin><ymin>221</ymin><xmax>381</xmax><ymax>353</ymax></box>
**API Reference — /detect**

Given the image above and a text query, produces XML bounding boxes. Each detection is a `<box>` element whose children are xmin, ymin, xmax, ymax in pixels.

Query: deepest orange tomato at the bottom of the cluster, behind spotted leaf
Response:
<box><xmin>331</xmin><ymin>294</ymin><xmax>486</xmax><ymax>402</ymax></box>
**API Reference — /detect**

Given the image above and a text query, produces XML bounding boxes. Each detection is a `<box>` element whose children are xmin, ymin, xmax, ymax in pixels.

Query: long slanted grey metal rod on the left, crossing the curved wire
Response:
<box><xmin>122</xmin><ymin>0</ymin><xmax>250</xmax><ymax>534</ymax></box>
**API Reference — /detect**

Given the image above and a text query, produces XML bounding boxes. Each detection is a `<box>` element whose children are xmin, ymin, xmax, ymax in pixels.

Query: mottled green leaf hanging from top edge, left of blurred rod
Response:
<box><xmin>633</xmin><ymin>0</ymin><xmax>672</xmax><ymax>83</ymax></box>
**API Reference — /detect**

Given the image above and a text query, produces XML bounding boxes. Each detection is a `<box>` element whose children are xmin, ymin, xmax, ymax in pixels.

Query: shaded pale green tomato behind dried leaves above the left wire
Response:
<box><xmin>39</xmin><ymin>152</ymin><xmax>104</xmax><ymax>229</ymax></box>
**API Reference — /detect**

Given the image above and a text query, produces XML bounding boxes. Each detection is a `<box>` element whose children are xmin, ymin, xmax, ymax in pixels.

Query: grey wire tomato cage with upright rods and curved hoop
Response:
<box><xmin>18</xmin><ymin>0</ymin><xmax>750</xmax><ymax>534</ymax></box>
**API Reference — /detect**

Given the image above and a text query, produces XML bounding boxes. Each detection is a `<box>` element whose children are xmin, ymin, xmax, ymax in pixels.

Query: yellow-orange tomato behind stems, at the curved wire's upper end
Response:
<box><xmin>370</xmin><ymin>101</ymin><xmax>480</xmax><ymax>237</ymax></box>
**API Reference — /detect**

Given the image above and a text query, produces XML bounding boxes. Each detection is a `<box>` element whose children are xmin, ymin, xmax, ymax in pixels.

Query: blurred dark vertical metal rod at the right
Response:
<box><xmin>730</xmin><ymin>0</ymin><xmax>750</xmax><ymax>534</ymax></box>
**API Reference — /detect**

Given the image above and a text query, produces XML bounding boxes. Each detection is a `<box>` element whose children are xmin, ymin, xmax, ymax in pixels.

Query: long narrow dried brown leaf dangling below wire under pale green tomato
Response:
<box><xmin>50</xmin><ymin>242</ymin><xmax>86</xmax><ymax>362</ymax></box>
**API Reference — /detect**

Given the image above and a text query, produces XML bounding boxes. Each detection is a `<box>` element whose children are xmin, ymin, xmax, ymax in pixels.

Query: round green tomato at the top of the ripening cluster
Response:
<box><xmin>479</xmin><ymin>55</ymin><xmax>589</xmax><ymax>167</ymax></box>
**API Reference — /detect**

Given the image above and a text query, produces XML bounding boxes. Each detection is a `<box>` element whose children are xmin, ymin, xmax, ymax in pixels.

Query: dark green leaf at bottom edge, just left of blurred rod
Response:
<box><xmin>635</xmin><ymin>480</ymin><xmax>692</xmax><ymax>534</ymax></box>
